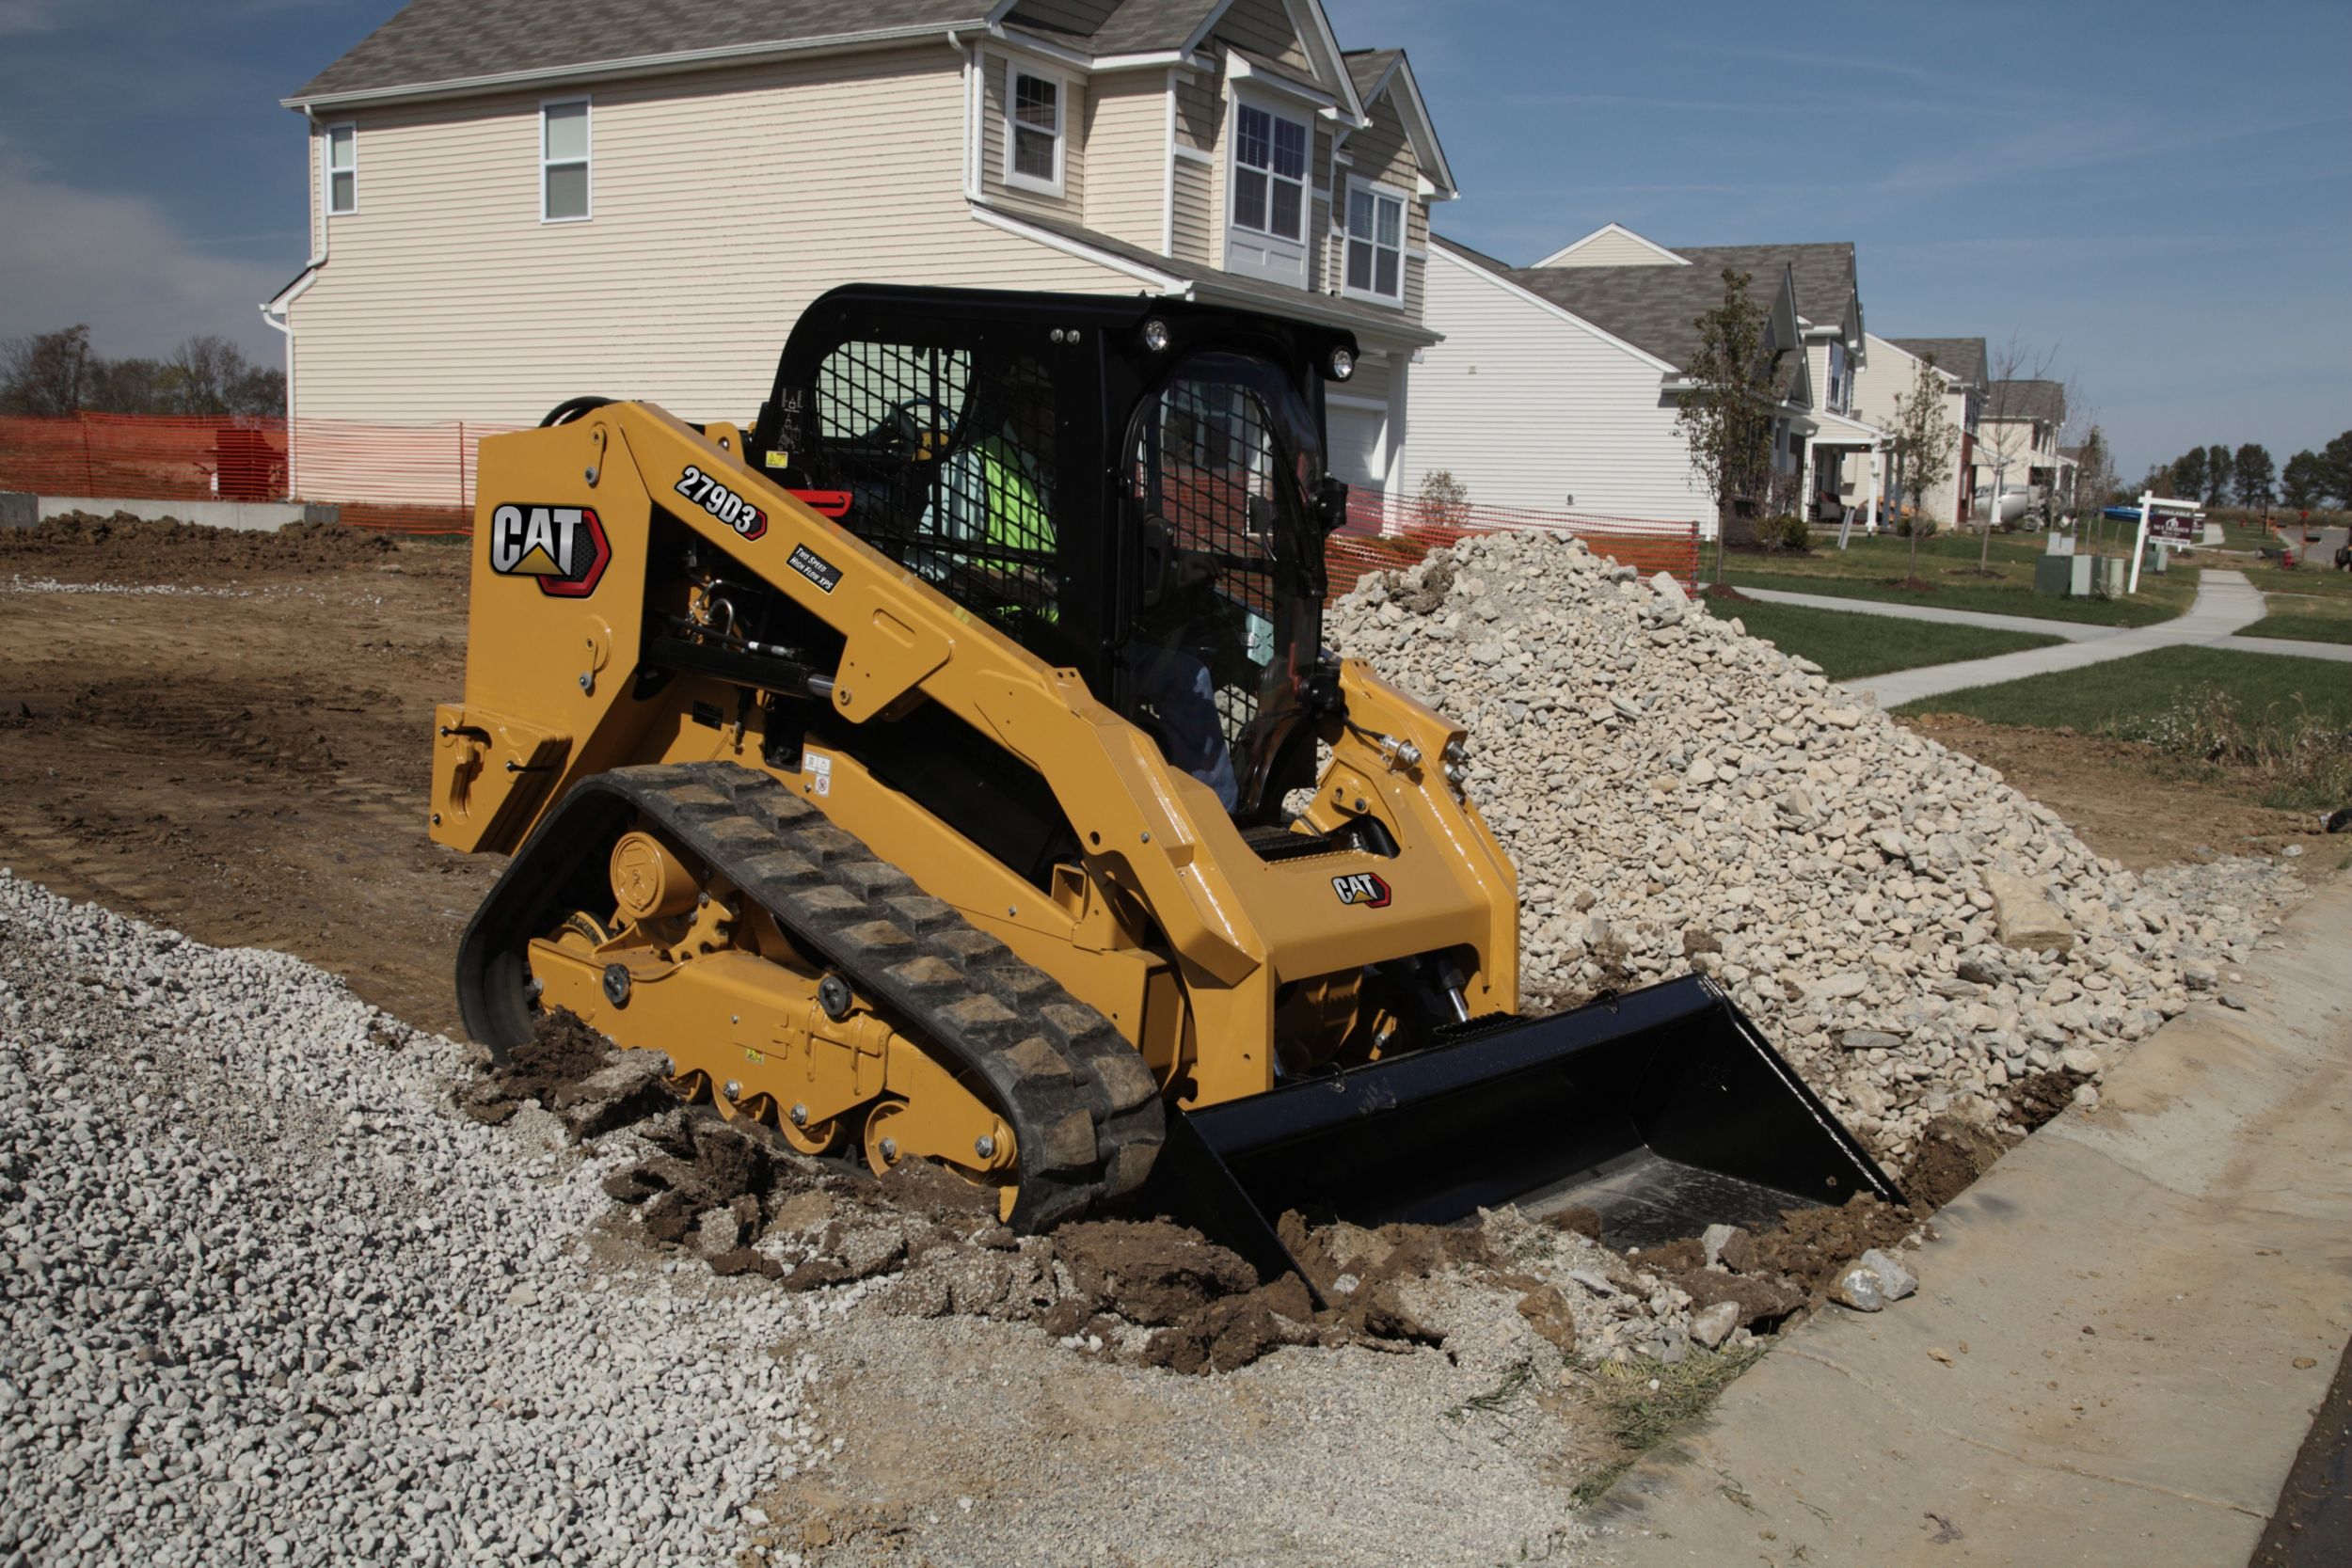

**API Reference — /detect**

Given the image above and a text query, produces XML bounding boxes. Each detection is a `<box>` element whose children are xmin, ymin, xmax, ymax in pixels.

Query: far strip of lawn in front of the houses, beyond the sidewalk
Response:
<box><xmin>1701</xmin><ymin>533</ymin><xmax>2197</xmax><ymax>626</ymax></box>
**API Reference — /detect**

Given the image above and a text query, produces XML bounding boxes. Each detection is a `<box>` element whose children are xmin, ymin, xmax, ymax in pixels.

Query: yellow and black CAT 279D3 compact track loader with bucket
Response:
<box><xmin>433</xmin><ymin>287</ymin><xmax>1894</xmax><ymax>1270</ymax></box>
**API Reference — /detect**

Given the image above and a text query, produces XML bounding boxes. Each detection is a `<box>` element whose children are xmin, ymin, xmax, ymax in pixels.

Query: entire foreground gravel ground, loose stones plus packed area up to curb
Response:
<box><xmin>0</xmin><ymin>872</ymin><xmax>1609</xmax><ymax>1568</ymax></box>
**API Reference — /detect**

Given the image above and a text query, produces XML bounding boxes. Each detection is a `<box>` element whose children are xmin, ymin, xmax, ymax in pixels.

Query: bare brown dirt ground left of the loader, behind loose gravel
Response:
<box><xmin>0</xmin><ymin>522</ymin><xmax>499</xmax><ymax>1032</ymax></box>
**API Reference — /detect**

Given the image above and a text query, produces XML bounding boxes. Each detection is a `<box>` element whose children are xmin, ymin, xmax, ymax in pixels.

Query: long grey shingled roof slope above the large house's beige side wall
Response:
<box><xmin>287</xmin><ymin>0</ymin><xmax>991</xmax><ymax>108</ymax></box>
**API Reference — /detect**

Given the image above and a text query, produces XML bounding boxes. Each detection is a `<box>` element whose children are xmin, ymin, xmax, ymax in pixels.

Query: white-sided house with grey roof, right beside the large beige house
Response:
<box><xmin>1402</xmin><ymin>223</ymin><xmax>1882</xmax><ymax>536</ymax></box>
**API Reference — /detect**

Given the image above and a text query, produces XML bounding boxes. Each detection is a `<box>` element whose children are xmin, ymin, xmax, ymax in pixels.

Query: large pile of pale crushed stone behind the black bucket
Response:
<box><xmin>1325</xmin><ymin>533</ymin><xmax>2303</xmax><ymax>1159</ymax></box>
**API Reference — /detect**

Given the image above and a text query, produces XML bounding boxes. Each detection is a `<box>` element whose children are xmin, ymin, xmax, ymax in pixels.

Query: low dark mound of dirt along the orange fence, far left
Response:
<box><xmin>0</xmin><ymin>513</ymin><xmax>400</xmax><ymax>578</ymax></box>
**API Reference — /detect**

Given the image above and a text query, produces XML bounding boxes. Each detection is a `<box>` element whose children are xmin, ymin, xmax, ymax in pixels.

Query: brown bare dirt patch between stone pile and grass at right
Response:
<box><xmin>1899</xmin><ymin>712</ymin><xmax>2317</xmax><ymax>870</ymax></box>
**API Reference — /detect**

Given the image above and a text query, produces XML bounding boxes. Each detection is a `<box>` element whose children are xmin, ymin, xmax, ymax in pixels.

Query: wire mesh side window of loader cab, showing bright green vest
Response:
<box><xmin>809</xmin><ymin>341</ymin><xmax>1066</xmax><ymax>637</ymax></box>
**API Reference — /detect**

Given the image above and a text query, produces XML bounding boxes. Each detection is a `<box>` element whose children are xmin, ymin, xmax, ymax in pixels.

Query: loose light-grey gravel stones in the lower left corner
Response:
<box><xmin>0</xmin><ymin>875</ymin><xmax>821</xmax><ymax>1568</ymax></box>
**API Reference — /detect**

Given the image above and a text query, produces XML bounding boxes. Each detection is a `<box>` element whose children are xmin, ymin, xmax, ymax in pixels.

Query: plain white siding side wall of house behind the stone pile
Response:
<box><xmin>1397</xmin><ymin>249</ymin><xmax>1712</xmax><ymax>527</ymax></box>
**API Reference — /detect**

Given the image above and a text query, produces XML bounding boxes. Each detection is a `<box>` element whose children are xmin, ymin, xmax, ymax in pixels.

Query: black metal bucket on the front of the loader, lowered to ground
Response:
<box><xmin>1148</xmin><ymin>975</ymin><xmax>1900</xmax><ymax>1276</ymax></box>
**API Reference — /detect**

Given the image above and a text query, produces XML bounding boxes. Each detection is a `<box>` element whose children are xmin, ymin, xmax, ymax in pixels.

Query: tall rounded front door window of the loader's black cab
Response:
<box><xmin>1129</xmin><ymin>355</ymin><xmax>1292</xmax><ymax>806</ymax></box>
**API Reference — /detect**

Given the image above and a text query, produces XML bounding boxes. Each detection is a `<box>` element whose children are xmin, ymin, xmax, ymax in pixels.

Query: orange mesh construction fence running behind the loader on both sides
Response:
<box><xmin>0</xmin><ymin>414</ymin><xmax>1698</xmax><ymax>594</ymax></box>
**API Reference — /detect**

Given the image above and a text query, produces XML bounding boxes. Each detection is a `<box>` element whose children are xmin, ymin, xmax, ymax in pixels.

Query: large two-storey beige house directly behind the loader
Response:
<box><xmin>263</xmin><ymin>0</ymin><xmax>1456</xmax><ymax>499</ymax></box>
